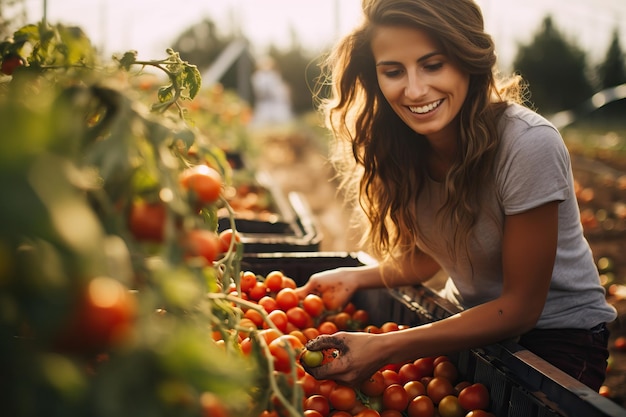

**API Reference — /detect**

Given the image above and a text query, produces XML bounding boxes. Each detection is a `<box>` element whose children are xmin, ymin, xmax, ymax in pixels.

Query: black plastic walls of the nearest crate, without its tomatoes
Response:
<box><xmin>242</xmin><ymin>252</ymin><xmax>626</xmax><ymax>417</ymax></box>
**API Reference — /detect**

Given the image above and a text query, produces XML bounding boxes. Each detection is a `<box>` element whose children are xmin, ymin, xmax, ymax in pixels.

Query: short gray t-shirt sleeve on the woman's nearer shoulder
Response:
<box><xmin>496</xmin><ymin>118</ymin><xmax>571</xmax><ymax>215</ymax></box>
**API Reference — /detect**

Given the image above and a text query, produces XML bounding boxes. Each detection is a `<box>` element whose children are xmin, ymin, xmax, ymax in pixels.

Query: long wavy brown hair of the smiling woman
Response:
<box><xmin>320</xmin><ymin>0</ymin><xmax>521</xmax><ymax>257</ymax></box>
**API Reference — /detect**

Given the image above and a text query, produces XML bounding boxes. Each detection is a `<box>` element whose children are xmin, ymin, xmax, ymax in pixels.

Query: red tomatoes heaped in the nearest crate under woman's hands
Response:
<box><xmin>214</xmin><ymin>271</ymin><xmax>494</xmax><ymax>417</ymax></box>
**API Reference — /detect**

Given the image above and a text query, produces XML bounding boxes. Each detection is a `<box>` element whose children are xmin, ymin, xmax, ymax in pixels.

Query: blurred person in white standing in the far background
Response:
<box><xmin>251</xmin><ymin>57</ymin><xmax>292</xmax><ymax>127</ymax></box>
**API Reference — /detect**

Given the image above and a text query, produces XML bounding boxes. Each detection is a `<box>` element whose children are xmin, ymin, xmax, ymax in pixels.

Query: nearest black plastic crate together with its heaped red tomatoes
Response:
<box><xmin>233</xmin><ymin>252</ymin><xmax>626</xmax><ymax>417</ymax></box>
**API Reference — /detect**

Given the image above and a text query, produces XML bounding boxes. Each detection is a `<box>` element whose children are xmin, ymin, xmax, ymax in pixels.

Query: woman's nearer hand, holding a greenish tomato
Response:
<box><xmin>303</xmin><ymin>332</ymin><xmax>386</xmax><ymax>387</ymax></box>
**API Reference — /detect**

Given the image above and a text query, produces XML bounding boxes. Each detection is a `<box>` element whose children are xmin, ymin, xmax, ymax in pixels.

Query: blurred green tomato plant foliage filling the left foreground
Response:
<box><xmin>0</xmin><ymin>23</ymin><xmax>280</xmax><ymax>417</ymax></box>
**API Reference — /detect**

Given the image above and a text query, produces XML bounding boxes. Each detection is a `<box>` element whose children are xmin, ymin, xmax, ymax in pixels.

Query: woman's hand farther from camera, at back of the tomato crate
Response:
<box><xmin>296</xmin><ymin>268</ymin><xmax>358</xmax><ymax>310</ymax></box>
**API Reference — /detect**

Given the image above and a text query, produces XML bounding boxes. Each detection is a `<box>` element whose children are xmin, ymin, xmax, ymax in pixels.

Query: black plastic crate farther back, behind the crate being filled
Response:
<box><xmin>218</xmin><ymin>172</ymin><xmax>322</xmax><ymax>253</ymax></box>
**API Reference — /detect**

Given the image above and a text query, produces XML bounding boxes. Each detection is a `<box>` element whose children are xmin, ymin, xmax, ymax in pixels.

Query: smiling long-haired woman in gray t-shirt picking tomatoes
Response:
<box><xmin>298</xmin><ymin>0</ymin><xmax>616</xmax><ymax>390</ymax></box>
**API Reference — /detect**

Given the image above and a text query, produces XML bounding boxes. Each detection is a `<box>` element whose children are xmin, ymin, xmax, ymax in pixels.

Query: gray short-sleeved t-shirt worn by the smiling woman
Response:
<box><xmin>418</xmin><ymin>101</ymin><xmax>617</xmax><ymax>329</ymax></box>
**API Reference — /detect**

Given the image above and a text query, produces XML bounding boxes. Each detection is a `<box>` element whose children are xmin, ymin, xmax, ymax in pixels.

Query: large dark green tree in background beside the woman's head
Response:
<box><xmin>513</xmin><ymin>16</ymin><xmax>593</xmax><ymax>114</ymax></box>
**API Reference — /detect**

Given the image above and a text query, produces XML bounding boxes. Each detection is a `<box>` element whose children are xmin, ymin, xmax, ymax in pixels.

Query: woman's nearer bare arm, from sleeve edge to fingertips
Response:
<box><xmin>307</xmin><ymin>202</ymin><xmax>558</xmax><ymax>385</ymax></box>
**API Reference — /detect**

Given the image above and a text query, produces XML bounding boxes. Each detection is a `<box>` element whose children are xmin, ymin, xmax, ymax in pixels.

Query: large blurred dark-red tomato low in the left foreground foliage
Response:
<box><xmin>55</xmin><ymin>277</ymin><xmax>136</xmax><ymax>352</ymax></box>
